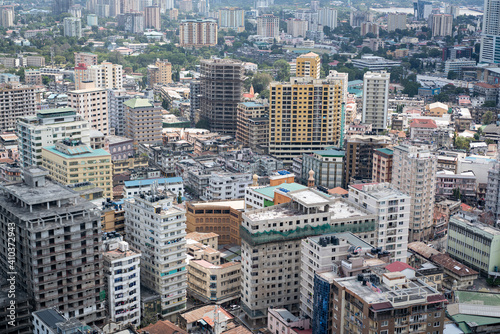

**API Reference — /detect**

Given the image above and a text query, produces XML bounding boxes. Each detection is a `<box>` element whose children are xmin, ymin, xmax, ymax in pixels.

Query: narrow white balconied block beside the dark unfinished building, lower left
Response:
<box><xmin>103</xmin><ymin>240</ymin><xmax>141</xmax><ymax>326</ymax></box>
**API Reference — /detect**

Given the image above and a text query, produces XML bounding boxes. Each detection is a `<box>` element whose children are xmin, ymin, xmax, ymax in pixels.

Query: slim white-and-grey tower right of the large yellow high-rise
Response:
<box><xmin>361</xmin><ymin>71</ymin><xmax>390</xmax><ymax>132</ymax></box>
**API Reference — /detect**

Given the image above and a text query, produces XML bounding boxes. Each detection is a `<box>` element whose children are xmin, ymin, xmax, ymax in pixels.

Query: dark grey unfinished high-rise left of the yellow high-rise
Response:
<box><xmin>200</xmin><ymin>59</ymin><xmax>244</xmax><ymax>136</ymax></box>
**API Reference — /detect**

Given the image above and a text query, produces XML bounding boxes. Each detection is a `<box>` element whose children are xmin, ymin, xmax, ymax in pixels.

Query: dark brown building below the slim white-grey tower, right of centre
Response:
<box><xmin>342</xmin><ymin>135</ymin><xmax>391</xmax><ymax>189</ymax></box>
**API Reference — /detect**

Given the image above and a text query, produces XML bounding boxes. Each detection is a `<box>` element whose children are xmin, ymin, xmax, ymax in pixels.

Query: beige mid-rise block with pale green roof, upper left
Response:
<box><xmin>123</xmin><ymin>98</ymin><xmax>162</xmax><ymax>145</ymax></box>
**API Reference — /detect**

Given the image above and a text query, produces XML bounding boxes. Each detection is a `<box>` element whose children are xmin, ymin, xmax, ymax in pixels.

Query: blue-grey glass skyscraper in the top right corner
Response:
<box><xmin>479</xmin><ymin>0</ymin><xmax>500</xmax><ymax>64</ymax></box>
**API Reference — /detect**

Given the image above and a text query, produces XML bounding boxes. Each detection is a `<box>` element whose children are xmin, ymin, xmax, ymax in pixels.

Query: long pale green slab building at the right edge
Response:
<box><xmin>446</xmin><ymin>215</ymin><xmax>500</xmax><ymax>277</ymax></box>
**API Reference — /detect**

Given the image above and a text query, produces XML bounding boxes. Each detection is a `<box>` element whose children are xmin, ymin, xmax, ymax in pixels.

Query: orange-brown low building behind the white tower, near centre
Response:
<box><xmin>186</xmin><ymin>200</ymin><xmax>245</xmax><ymax>245</ymax></box>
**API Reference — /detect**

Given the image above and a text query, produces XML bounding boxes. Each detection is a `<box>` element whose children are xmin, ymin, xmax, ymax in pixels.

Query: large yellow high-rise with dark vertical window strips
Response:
<box><xmin>269</xmin><ymin>71</ymin><xmax>347</xmax><ymax>163</ymax></box>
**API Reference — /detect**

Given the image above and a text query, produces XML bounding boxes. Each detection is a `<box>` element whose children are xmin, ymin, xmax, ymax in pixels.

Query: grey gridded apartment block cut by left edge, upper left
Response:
<box><xmin>0</xmin><ymin>85</ymin><xmax>37</xmax><ymax>132</ymax></box>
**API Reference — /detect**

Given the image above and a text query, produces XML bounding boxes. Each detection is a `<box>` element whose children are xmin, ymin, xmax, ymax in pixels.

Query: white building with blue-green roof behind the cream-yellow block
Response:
<box><xmin>16</xmin><ymin>108</ymin><xmax>90</xmax><ymax>167</ymax></box>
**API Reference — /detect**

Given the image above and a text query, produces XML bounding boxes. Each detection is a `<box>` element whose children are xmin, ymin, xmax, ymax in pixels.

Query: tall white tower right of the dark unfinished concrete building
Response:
<box><xmin>124</xmin><ymin>187</ymin><xmax>187</xmax><ymax>320</ymax></box>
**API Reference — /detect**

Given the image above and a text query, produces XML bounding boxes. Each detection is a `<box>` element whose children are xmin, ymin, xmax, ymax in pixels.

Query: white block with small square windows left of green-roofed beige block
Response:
<box><xmin>68</xmin><ymin>82</ymin><xmax>109</xmax><ymax>136</ymax></box>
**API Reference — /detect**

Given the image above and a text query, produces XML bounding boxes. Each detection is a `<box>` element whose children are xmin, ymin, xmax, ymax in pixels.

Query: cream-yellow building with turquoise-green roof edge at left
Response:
<box><xmin>42</xmin><ymin>138</ymin><xmax>113</xmax><ymax>199</ymax></box>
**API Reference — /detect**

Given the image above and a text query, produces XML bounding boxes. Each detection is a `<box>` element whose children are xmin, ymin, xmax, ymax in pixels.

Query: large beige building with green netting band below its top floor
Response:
<box><xmin>240</xmin><ymin>189</ymin><xmax>377</xmax><ymax>325</ymax></box>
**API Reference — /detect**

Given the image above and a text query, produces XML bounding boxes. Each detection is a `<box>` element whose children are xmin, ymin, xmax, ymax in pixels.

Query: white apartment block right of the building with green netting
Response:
<box><xmin>349</xmin><ymin>183</ymin><xmax>411</xmax><ymax>262</ymax></box>
